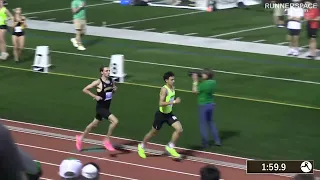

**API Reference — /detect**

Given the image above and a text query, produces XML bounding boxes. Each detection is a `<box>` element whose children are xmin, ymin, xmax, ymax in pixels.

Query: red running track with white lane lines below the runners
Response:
<box><xmin>1</xmin><ymin>120</ymin><xmax>314</xmax><ymax>180</ymax></box>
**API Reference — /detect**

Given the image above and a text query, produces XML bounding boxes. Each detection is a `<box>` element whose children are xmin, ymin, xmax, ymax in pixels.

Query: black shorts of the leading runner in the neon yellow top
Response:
<box><xmin>152</xmin><ymin>110</ymin><xmax>178</xmax><ymax>130</ymax></box>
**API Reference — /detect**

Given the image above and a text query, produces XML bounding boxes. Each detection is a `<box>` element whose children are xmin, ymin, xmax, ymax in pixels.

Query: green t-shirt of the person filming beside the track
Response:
<box><xmin>198</xmin><ymin>79</ymin><xmax>217</xmax><ymax>105</ymax></box>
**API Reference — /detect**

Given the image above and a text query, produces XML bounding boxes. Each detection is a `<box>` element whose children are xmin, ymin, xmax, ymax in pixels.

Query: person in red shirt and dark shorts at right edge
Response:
<box><xmin>304</xmin><ymin>0</ymin><xmax>320</xmax><ymax>59</ymax></box>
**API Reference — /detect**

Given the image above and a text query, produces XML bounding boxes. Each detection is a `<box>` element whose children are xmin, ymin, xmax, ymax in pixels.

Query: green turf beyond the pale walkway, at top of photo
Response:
<box><xmin>10</xmin><ymin>0</ymin><xmax>320</xmax><ymax>47</ymax></box>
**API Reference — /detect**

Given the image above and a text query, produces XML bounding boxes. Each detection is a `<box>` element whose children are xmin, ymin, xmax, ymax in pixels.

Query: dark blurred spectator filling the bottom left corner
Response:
<box><xmin>0</xmin><ymin>123</ymin><xmax>27</xmax><ymax>180</ymax></box>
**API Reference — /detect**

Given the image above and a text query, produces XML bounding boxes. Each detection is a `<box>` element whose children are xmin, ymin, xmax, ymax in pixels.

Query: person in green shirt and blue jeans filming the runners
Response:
<box><xmin>192</xmin><ymin>69</ymin><xmax>221</xmax><ymax>148</ymax></box>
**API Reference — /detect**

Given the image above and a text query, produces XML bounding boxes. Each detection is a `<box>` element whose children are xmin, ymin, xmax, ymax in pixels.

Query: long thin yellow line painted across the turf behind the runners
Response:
<box><xmin>0</xmin><ymin>65</ymin><xmax>320</xmax><ymax>110</ymax></box>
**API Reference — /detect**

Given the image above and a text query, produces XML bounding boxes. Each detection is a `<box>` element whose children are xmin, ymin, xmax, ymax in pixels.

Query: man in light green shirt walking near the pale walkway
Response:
<box><xmin>71</xmin><ymin>0</ymin><xmax>87</xmax><ymax>51</ymax></box>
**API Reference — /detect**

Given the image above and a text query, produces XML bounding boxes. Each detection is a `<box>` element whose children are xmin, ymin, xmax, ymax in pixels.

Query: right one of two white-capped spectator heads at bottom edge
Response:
<box><xmin>80</xmin><ymin>162</ymin><xmax>100</xmax><ymax>180</ymax></box>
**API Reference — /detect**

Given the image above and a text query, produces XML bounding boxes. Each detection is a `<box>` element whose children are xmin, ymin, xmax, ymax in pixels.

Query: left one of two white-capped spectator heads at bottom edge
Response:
<box><xmin>59</xmin><ymin>158</ymin><xmax>82</xmax><ymax>180</ymax></box>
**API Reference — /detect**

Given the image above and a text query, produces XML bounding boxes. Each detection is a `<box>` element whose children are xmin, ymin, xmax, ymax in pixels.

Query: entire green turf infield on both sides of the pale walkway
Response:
<box><xmin>0</xmin><ymin>0</ymin><xmax>320</xmax><ymax>168</ymax></box>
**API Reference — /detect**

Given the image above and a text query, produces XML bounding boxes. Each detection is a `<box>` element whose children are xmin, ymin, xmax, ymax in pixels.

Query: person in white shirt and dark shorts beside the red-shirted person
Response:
<box><xmin>287</xmin><ymin>0</ymin><xmax>304</xmax><ymax>56</ymax></box>
